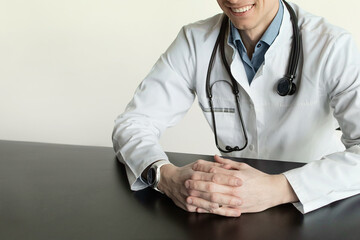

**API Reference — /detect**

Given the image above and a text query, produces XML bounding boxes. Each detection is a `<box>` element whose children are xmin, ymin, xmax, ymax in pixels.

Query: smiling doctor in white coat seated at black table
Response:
<box><xmin>113</xmin><ymin>0</ymin><xmax>360</xmax><ymax>216</ymax></box>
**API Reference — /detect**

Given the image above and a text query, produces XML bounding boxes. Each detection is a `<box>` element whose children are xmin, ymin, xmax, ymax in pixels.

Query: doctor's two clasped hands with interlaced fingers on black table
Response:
<box><xmin>158</xmin><ymin>156</ymin><xmax>292</xmax><ymax>217</ymax></box>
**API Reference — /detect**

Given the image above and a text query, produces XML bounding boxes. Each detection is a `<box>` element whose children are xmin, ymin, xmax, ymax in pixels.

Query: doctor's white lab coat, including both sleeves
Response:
<box><xmin>113</xmin><ymin>4</ymin><xmax>360</xmax><ymax>213</ymax></box>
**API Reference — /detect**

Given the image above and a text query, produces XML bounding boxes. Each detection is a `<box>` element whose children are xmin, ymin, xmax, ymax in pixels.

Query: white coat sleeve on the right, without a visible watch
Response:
<box><xmin>284</xmin><ymin>33</ymin><xmax>360</xmax><ymax>213</ymax></box>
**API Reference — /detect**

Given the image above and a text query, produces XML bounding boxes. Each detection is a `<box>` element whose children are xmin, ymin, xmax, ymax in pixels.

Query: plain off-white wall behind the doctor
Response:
<box><xmin>0</xmin><ymin>0</ymin><xmax>360</xmax><ymax>154</ymax></box>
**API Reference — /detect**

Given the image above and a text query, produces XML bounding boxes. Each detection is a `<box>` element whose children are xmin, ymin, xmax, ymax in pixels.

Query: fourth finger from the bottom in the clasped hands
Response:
<box><xmin>191</xmin><ymin>172</ymin><xmax>242</xmax><ymax>187</ymax></box>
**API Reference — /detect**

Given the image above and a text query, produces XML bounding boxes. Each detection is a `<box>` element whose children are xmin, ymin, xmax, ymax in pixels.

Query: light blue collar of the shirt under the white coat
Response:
<box><xmin>229</xmin><ymin>0</ymin><xmax>284</xmax><ymax>52</ymax></box>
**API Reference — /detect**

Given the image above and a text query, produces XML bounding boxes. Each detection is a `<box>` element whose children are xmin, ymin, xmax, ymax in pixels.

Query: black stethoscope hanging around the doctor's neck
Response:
<box><xmin>206</xmin><ymin>1</ymin><xmax>302</xmax><ymax>153</ymax></box>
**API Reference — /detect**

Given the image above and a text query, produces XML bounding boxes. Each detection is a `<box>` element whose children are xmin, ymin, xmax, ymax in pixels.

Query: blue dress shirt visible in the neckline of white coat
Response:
<box><xmin>229</xmin><ymin>0</ymin><xmax>284</xmax><ymax>84</ymax></box>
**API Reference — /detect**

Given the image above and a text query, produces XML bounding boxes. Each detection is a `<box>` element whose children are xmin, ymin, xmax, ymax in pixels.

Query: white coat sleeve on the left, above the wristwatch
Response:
<box><xmin>112</xmin><ymin>28</ymin><xmax>195</xmax><ymax>191</ymax></box>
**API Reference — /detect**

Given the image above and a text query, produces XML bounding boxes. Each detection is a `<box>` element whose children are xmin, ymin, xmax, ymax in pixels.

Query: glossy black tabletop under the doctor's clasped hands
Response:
<box><xmin>0</xmin><ymin>141</ymin><xmax>360</xmax><ymax>240</ymax></box>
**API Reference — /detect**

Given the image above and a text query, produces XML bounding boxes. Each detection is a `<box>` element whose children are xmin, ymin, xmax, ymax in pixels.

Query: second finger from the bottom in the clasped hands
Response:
<box><xmin>187</xmin><ymin>190</ymin><xmax>242</xmax><ymax>207</ymax></box>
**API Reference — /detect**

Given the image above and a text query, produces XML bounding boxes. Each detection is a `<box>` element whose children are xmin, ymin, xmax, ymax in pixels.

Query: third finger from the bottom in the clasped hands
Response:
<box><xmin>185</xmin><ymin>180</ymin><xmax>236</xmax><ymax>195</ymax></box>
